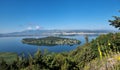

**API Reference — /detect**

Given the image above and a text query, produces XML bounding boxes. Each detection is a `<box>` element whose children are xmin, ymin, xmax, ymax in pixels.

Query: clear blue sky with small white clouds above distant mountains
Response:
<box><xmin>0</xmin><ymin>0</ymin><xmax>120</xmax><ymax>33</ymax></box>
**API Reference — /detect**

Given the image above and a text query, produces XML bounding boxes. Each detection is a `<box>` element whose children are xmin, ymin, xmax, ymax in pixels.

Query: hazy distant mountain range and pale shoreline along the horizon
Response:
<box><xmin>0</xmin><ymin>30</ymin><xmax>114</xmax><ymax>37</ymax></box>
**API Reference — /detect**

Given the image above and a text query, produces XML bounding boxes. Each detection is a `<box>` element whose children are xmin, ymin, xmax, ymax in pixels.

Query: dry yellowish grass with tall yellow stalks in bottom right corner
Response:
<box><xmin>84</xmin><ymin>43</ymin><xmax>120</xmax><ymax>70</ymax></box>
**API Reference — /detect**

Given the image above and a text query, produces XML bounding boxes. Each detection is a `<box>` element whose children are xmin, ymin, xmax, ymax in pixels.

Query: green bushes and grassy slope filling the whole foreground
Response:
<box><xmin>0</xmin><ymin>33</ymin><xmax>120</xmax><ymax>70</ymax></box>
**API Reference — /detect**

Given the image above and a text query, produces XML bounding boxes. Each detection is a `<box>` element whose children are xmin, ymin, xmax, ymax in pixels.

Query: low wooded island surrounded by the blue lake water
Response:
<box><xmin>22</xmin><ymin>36</ymin><xmax>81</xmax><ymax>46</ymax></box>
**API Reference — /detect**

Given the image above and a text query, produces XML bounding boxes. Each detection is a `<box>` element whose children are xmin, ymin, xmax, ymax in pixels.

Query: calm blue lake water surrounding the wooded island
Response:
<box><xmin>0</xmin><ymin>36</ymin><xmax>97</xmax><ymax>55</ymax></box>
